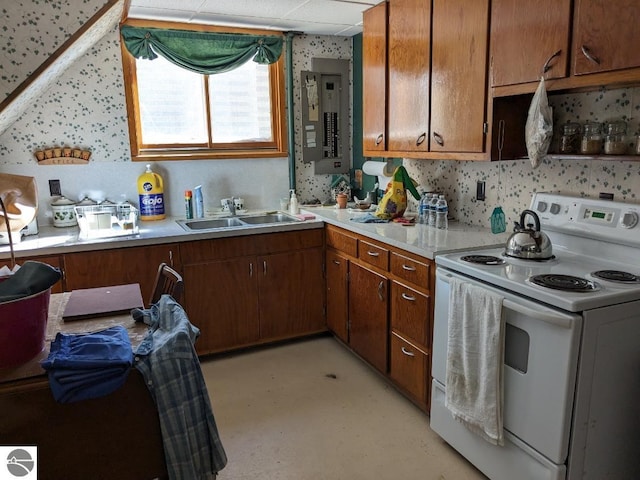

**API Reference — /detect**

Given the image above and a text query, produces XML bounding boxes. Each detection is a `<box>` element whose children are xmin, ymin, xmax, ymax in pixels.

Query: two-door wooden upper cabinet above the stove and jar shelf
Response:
<box><xmin>489</xmin><ymin>0</ymin><xmax>640</xmax><ymax>97</ymax></box>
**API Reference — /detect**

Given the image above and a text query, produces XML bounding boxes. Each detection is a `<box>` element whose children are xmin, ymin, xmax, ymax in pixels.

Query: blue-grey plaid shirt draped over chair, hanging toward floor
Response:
<box><xmin>132</xmin><ymin>295</ymin><xmax>227</xmax><ymax>480</ymax></box>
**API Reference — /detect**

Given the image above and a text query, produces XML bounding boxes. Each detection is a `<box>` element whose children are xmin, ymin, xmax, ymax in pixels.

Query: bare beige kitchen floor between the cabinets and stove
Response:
<box><xmin>202</xmin><ymin>337</ymin><xmax>485</xmax><ymax>480</ymax></box>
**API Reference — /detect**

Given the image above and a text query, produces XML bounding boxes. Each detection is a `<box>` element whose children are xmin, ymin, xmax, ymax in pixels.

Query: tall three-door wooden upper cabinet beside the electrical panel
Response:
<box><xmin>363</xmin><ymin>0</ymin><xmax>489</xmax><ymax>159</ymax></box>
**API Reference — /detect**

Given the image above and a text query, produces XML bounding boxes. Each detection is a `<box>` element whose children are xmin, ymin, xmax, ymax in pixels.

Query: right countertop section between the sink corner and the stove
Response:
<box><xmin>305</xmin><ymin>207</ymin><xmax>510</xmax><ymax>260</ymax></box>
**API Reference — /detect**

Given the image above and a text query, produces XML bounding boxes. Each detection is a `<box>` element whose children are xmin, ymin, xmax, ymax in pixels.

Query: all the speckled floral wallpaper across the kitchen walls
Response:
<box><xmin>0</xmin><ymin>0</ymin><xmax>640</xmax><ymax>232</ymax></box>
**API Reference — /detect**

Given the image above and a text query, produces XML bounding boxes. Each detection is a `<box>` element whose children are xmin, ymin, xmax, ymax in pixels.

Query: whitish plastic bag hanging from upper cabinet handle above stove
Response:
<box><xmin>525</xmin><ymin>77</ymin><xmax>553</xmax><ymax>168</ymax></box>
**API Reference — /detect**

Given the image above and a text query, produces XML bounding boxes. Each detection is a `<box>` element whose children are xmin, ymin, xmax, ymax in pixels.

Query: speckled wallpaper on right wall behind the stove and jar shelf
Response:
<box><xmin>403</xmin><ymin>88</ymin><xmax>640</xmax><ymax>230</ymax></box>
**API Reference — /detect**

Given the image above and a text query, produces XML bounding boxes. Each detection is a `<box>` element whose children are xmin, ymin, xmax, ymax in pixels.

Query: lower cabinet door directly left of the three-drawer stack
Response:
<box><xmin>349</xmin><ymin>263</ymin><xmax>389</xmax><ymax>373</ymax></box>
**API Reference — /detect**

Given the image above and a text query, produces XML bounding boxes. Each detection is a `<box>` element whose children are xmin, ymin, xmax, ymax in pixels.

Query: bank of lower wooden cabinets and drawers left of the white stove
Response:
<box><xmin>325</xmin><ymin>225</ymin><xmax>434</xmax><ymax>412</ymax></box>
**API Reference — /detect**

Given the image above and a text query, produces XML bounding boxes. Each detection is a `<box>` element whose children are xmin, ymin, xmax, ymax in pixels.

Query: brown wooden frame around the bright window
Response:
<box><xmin>120</xmin><ymin>19</ymin><xmax>288</xmax><ymax>162</ymax></box>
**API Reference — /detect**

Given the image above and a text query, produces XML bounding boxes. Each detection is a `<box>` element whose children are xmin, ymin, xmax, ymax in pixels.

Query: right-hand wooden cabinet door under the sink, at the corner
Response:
<box><xmin>257</xmin><ymin>248</ymin><xmax>326</xmax><ymax>340</ymax></box>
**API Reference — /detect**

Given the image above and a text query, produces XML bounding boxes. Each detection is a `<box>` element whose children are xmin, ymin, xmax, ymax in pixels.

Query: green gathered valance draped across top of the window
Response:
<box><xmin>120</xmin><ymin>25</ymin><xmax>283</xmax><ymax>74</ymax></box>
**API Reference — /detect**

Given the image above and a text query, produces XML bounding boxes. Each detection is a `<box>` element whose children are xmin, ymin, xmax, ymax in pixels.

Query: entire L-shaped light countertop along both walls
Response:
<box><xmin>0</xmin><ymin>207</ymin><xmax>509</xmax><ymax>258</ymax></box>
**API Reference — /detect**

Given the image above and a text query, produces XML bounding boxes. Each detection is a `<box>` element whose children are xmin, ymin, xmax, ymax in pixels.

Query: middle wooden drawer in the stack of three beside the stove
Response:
<box><xmin>391</xmin><ymin>281</ymin><xmax>431</xmax><ymax>351</ymax></box>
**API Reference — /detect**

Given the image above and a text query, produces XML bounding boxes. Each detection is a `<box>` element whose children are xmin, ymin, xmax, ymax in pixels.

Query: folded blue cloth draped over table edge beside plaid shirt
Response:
<box><xmin>42</xmin><ymin>325</ymin><xmax>133</xmax><ymax>403</ymax></box>
